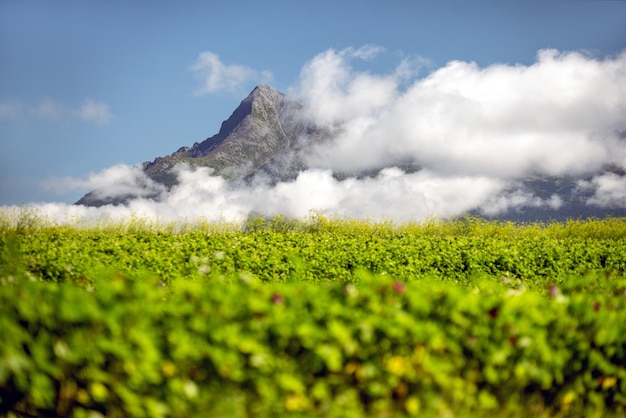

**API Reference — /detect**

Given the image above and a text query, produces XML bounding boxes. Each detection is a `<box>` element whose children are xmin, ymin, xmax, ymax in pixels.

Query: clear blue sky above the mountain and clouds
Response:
<box><xmin>0</xmin><ymin>0</ymin><xmax>626</xmax><ymax>205</ymax></box>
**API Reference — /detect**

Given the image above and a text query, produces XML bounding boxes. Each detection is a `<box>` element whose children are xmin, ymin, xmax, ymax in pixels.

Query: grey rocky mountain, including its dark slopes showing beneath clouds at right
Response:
<box><xmin>76</xmin><ymin>85</ymin><xmax>626</xmax><ymax>221</ymax></box>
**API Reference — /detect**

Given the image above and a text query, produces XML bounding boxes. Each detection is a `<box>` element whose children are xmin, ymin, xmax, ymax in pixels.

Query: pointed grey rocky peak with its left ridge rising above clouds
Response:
<box><xmin>76</xmin><ymin>85</ymin><xmax>330</xmax><ymax>206</ymax></box>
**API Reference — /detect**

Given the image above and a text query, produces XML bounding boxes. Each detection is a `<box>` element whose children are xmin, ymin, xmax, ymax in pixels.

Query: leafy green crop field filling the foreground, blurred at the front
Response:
<box><xmin>0</xmin><ymin>216</ymin><xmax>626</xmax><ymax>417</ymax></box>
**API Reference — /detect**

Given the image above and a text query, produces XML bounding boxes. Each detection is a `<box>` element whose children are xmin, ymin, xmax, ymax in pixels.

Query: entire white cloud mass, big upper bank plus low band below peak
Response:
<box><xmin>4</xmin><ymin>47</ymin><xmax>626</xmax><ymax>223</ymax></box>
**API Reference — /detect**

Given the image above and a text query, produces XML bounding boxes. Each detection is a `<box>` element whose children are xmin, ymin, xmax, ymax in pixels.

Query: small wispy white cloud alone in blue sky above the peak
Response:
<box><xmin>191</xmin><ymin>51</ymin><xmax>272</xmax><ymax>95</ymax></box>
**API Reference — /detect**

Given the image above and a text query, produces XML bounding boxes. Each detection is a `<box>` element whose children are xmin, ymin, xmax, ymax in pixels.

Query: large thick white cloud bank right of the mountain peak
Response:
<box><xmin>297</xmin><ymin>50</ymin><xmax>626</xmax><ymax>178</ymax></box>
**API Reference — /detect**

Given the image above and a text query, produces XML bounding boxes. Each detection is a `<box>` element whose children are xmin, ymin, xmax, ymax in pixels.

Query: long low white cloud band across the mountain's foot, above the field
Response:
<box><xmin>8</xmin><ymin>165</ymin><xmax>505</xmax><ymax>224</ymax></box>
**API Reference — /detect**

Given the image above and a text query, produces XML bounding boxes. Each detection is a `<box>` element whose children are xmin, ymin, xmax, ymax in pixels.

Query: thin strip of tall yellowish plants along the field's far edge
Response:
<box><xmin>0</xmin><ymin>207</ymin><xmax>626</xmax><ymax>239</ymax></box>
